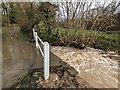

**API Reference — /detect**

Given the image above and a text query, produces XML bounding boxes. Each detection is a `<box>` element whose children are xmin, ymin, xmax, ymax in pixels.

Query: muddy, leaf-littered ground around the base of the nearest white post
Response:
<box><xmin>12</xmin><ymin>66</ymin><xmax>93</xmax><ymax>88</ymax></box>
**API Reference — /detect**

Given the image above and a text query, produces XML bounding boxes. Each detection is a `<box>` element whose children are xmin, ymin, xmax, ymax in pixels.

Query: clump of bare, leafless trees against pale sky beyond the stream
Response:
<box><xmin>58</xmin><ymin>0</ymin><xmax>119</xmax><ymax>31</ymax></box>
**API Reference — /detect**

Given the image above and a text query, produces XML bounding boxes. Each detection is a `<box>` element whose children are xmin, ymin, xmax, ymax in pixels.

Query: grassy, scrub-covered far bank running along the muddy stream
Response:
<box><xmin>39</xmin><ymin>28</ymin><xmax>120</xmax><ymax>51</ymax></box>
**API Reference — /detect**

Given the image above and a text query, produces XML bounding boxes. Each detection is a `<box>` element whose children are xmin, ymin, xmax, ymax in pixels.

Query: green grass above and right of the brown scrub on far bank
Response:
<box><xmin>54</xmin><ymin>29</ymin><xmax>120</xmax><ymax>51</ymax></box>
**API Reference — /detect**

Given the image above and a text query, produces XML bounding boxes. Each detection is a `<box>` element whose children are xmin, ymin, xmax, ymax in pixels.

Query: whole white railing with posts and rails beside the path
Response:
<box><xmin>33</xmin><ymin>28</ymin><xmax>50</xmax><ymax>80</ymax></box>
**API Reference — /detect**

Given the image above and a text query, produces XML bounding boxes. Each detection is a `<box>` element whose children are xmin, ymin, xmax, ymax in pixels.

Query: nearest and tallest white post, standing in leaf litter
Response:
<box><xmin>44</xmin><ymin>42</ymin><xmax>50</xmax><ymax>80</ymax></box>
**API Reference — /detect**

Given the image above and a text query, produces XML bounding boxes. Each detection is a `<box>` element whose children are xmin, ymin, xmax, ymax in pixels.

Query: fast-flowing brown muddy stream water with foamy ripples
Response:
<box><xmin>51</xmin><ymin>46</ymin><xmax>120</xmax><ymax>88</ymax></box>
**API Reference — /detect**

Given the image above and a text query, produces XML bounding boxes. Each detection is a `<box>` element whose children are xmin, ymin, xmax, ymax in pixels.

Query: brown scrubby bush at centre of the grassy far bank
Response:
<box><xmin>57</xmin><ymin>29</ymin><xmax>96</xmax><ymax>48</ymax></box>
